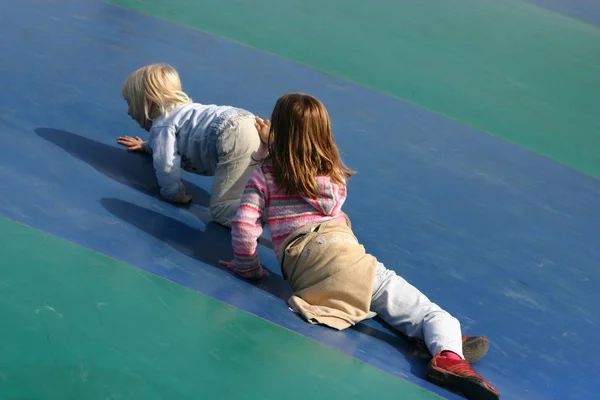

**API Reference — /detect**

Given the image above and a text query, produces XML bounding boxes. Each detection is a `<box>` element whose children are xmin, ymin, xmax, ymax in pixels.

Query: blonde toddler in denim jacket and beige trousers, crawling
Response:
<box><xmin>117</xmin><ymin>64</ymin><xmax>266</xmax><ymax>227</ymax></box>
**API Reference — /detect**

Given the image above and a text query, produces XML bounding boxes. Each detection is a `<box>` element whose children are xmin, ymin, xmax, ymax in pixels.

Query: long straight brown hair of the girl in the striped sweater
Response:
<box><xmin>267</xmin><ymin>93</ymin><xmax>356</xmax><ymax>198</ymax></box>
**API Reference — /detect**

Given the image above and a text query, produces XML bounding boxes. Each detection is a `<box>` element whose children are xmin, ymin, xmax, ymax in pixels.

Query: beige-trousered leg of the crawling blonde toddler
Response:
<box><xmin>210</xmin><ymin>116</ymin><xmax>265</xmax><ymax>227</ymax></box>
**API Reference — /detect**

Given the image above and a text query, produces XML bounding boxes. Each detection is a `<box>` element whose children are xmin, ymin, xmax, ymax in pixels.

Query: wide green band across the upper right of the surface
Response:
<box><xmin>108</xmin><ymin>0</ymin><xmax>600</xmax><ymax>177</ymax></box>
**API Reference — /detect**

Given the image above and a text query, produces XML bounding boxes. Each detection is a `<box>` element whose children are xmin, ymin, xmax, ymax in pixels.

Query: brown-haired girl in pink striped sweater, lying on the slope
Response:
<box><xmin>221</xmin><ymin>93</ymin><xmax>500</xmax><ymax>400</ymax></box>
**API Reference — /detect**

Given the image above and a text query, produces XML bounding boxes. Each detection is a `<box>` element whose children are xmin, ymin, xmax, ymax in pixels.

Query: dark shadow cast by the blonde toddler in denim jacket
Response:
<box><xmin>35</xmin><ymin>128</ymin><xmax>210</xmax><ymax>206</ymax></box>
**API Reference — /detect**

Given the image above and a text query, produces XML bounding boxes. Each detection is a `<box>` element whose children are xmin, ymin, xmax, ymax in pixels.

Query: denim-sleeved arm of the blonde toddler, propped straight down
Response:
<box><xmin>146</xmin><ymin>127</ymin><xmax>191</xmax><ymax>203</ymax></box>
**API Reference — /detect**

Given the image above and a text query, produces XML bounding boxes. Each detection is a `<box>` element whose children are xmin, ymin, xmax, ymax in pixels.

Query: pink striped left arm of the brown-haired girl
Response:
<box><xmin>231</xmin><ymin>168</ymin><xmax>267</xmax><ymax>279</ymax></box>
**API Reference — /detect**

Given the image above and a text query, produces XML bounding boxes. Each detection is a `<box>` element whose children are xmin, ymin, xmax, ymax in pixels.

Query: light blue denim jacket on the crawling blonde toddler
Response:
<box><xmin>145</xmin><ymin>103</ymin><xmax>252</xmax><ymax>201</ymax></box>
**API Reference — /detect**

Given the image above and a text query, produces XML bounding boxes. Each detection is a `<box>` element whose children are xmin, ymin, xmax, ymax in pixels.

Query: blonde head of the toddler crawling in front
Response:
<box><xmin>121</xmin><ymin>64</ymin><xmax>192</xmax><ymax>126</ymax></box>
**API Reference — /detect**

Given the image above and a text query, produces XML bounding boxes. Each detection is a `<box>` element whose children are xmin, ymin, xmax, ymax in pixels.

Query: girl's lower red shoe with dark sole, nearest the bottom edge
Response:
<box><xmin>427</xmin><ymin>353</ymin><xmax>500</xmax><ymax>400</ymax></box>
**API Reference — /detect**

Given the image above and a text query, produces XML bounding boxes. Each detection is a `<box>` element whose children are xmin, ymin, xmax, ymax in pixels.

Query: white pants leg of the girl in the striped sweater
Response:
<box><xmin>371</xmin><ymin>263</ymin><xmax>464</xmax><ymax>358</ymax></box>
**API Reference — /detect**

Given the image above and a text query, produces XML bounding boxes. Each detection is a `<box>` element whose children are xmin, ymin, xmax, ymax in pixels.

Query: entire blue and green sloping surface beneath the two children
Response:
<box><xmin>0</xmin><ymin>0</ymin><xmax>600</xmax><ymax>400</ymax></box>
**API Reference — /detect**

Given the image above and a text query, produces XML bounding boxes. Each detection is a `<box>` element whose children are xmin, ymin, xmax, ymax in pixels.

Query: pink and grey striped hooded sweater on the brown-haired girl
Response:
<box><xmin>231</xmin><ymin>161</ymin><xmax>346</xmax><ymax>279</ymax></box>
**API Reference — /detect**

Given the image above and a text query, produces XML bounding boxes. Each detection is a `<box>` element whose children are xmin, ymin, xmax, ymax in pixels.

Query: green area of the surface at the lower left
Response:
<box><xmin>0</xmin><ymin>219</ymin><xmax>439</xmax><ymax>400</ymax></box>
